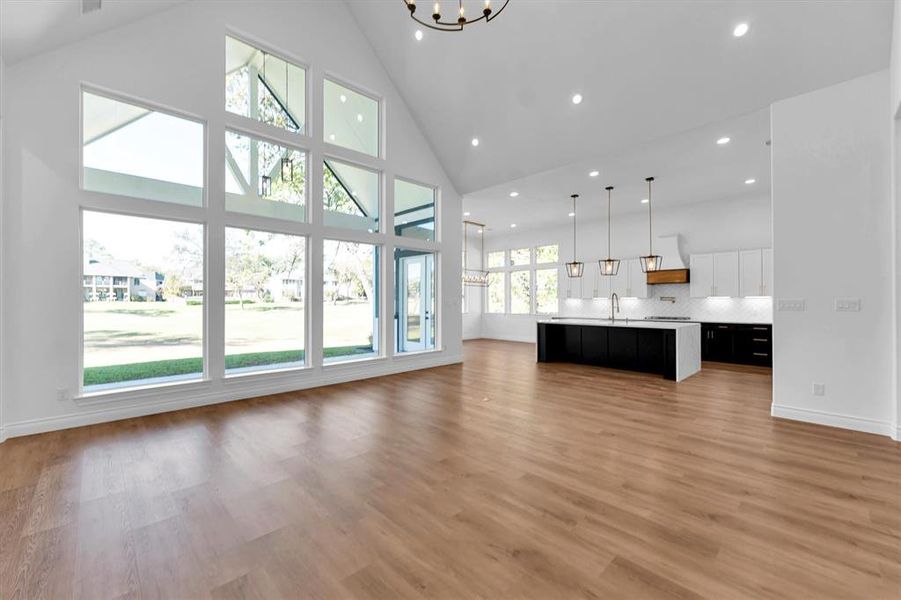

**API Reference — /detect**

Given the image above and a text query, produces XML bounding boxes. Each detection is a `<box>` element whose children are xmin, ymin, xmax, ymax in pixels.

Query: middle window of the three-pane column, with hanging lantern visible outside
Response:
<box><xmin>225</xmin><ymin>131</ymin><xmax>307</xmax><ymax>221</ymax></box>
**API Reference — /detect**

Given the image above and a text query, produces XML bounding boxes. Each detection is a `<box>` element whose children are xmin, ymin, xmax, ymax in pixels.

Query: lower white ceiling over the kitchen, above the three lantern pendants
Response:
<box><xmin>463</xmin><ymin>108</ymin><xmax>770</xmax><ymax>232</ymax></box>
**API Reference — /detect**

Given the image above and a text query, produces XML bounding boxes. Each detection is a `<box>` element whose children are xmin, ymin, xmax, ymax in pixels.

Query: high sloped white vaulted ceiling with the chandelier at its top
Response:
<box><xmin>347</xmin><ymin>0</ymin><xmax>892</xmax><ymax>193</ymax></box>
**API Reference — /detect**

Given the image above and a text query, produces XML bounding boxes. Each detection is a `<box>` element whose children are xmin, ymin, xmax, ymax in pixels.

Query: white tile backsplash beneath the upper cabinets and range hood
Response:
<box><xmin>560</xmin><ymin>284</ymin><xmax>773</xmax><ymax>323</ymax></box>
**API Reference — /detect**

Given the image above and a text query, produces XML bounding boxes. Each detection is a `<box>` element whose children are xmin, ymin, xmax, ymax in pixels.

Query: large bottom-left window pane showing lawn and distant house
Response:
<box><xmin>82</xmin><ymin>211</ymin><xmax>204</xmax><ymax>391</ymax></box>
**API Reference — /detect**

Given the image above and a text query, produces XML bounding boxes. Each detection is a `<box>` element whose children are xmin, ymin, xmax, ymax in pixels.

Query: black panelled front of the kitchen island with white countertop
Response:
<box><xmin>538</xmin><ymin>323</ymin><xmax>676</xmax><ymax>380</ymax></box>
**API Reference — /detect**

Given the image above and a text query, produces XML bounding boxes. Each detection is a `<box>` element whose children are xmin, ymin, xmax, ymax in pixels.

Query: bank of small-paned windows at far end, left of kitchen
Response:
<box><xmin>486</xmin><ymin>245</ymin><xmax>560</xmax><ymax>315</ymax></box>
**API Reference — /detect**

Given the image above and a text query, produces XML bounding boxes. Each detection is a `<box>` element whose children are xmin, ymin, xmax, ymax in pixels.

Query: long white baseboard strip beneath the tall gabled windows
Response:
<box><xmin>0</xmin><ymin>354</ymin><xmax>463</xmax><ymax>443</ymax></box>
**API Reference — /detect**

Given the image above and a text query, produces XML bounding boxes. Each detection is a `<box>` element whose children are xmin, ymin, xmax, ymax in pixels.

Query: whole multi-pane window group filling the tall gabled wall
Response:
<box><xmin>79</xmin><ymin>36</ymin><xmax>440</xmax><ymax>393</ymax></box>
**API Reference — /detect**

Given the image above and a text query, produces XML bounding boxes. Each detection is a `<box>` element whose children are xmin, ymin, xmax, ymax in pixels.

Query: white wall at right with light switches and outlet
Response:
<box><xmin>771</xmin><ymin>71</ymin><xmax>897</xmax><ymax>434</ymax></box>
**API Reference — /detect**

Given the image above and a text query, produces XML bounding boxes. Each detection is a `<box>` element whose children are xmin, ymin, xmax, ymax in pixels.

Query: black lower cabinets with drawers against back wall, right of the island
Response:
<box><xmin>701</xmin><ymin>323</ymin><xmax>773</xmax><ymax>367</ymax></box>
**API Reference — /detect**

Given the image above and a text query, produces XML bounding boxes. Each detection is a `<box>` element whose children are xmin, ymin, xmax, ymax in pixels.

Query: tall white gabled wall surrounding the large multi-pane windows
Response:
<box><xmin>2</xmin><ymin>1</ymin><xmax>462</xmax><ymax>435</ymax></box>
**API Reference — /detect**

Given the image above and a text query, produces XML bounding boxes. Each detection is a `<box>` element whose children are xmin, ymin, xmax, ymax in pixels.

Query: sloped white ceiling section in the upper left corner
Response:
<box><xmin>0</xmin><ymin>0</ymin><xmax>185</xmax><ymax>65</ymax></box>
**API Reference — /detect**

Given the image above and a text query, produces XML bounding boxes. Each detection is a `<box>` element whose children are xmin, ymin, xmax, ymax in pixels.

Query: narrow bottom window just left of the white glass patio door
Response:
<box><xmin>322</xmin><ymin>240</ymin><xmax>379</xmax><ymax>362</ymax></box>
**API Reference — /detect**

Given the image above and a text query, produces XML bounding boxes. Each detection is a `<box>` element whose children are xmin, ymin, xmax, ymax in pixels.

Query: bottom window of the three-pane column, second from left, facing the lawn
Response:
<box><xmin>225</xmin><ymin>228</ymin><xmax>306</xmax><ymax>373</ymax></box>
